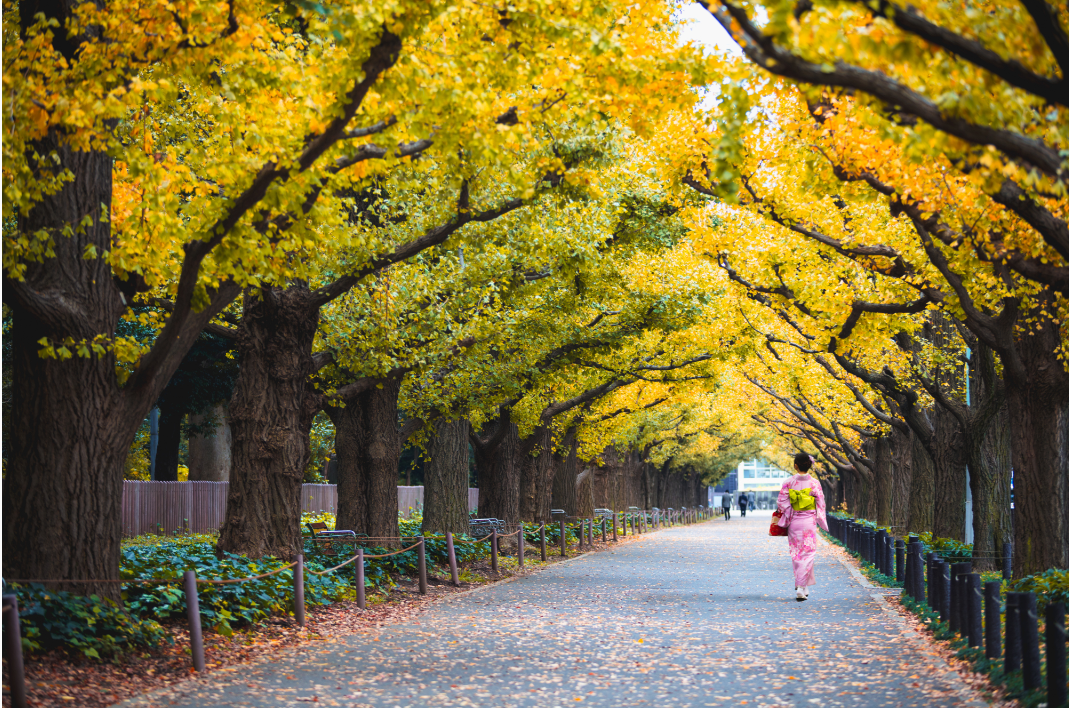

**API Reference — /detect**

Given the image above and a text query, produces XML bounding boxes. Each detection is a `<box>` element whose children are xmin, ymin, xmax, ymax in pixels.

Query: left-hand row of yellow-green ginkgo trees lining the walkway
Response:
<box><xmin>3</xmin><ymin>0</ymin><xmax>752</xmax><ymax>596</ymax></box>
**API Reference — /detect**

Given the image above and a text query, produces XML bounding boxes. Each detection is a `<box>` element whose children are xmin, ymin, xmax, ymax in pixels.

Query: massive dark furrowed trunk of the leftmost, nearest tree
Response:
<box><xmin>3</xmin><ymin>131</ymin><xmax>131</xmax><ymax>599</ymax></box>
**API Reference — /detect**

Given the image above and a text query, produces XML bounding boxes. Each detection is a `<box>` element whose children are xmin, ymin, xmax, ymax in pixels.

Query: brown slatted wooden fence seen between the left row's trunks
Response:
<box><xmin>122</xmin><ymin>481</ymin><xmax>479</xmax><ymax>536</ymax></box>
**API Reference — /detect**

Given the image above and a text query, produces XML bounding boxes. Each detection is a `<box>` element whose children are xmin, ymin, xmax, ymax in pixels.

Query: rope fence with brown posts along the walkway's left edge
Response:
<box><xmin>3</xmin><ymin>507</ymin><xmax>719</xmax><ymax>708</ymax></box>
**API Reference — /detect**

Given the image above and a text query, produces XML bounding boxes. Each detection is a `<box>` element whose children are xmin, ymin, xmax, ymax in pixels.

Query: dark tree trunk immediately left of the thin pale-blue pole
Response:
<box><xmin>932</xmin><ymin>406</ymin><xmax>965</xmax><ymax>542</ymax></box>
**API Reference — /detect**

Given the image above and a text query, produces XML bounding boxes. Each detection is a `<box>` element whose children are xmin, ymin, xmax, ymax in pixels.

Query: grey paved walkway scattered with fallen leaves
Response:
<box><xmin>126</xmin><ymin>512</ymin><xmax>983</xmax><ymax>708</ymax></box>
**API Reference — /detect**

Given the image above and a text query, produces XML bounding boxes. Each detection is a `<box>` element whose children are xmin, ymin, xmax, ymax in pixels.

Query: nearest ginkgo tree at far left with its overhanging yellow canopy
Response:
<box><xmin>3</xmin><ymin>0</ymin><xmax>709</xmax><ymax>597</ymax></box>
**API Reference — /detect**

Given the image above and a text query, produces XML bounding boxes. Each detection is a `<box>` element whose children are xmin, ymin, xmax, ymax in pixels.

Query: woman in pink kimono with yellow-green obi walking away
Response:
<box><xmin>777</xmin><ymin>452</ymin><xmax>827</xmax><ymax>602</ymax></box>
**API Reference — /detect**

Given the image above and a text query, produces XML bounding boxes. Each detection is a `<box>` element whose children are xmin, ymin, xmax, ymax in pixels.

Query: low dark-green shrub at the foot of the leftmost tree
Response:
<box><xmin>11</xmin><ymin>584</ymin><xmax>171</xmax><ymax>660</ymax></box>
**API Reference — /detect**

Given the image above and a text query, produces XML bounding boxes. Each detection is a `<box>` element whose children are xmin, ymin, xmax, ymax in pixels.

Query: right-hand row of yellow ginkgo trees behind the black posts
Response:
<box><xmin>686</xmin><ymin>0</ymin><xmax>1069</xmax><ymax>575</ymax></box>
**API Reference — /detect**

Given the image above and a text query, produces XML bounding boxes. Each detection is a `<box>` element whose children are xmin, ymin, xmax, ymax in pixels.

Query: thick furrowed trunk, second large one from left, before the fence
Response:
<box><xmin>218</xmin><ymin>284</ymin><xmax>319</xmax><ymax>558</ymax></box>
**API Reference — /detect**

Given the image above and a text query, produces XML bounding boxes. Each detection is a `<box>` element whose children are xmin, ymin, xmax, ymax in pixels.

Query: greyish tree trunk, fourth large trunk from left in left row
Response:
<box><xmin>423</xmin><ymin>418</ymin><xmax>471</xmax><ymax>535</ymax></box>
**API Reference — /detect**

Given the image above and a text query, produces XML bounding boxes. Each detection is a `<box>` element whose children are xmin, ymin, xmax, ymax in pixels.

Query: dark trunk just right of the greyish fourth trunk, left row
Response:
<box><xmin>471</xmin><ymin>412</ymin><xmax>521</xmax><ymax>523</ymax></box>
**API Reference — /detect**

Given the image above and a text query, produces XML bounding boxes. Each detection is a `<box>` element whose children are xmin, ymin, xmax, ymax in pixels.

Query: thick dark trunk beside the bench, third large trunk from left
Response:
<box><xmin>327</xmin><ymin>376</ymin><xmax>401</xmax><ymax>538</ymax></box>
